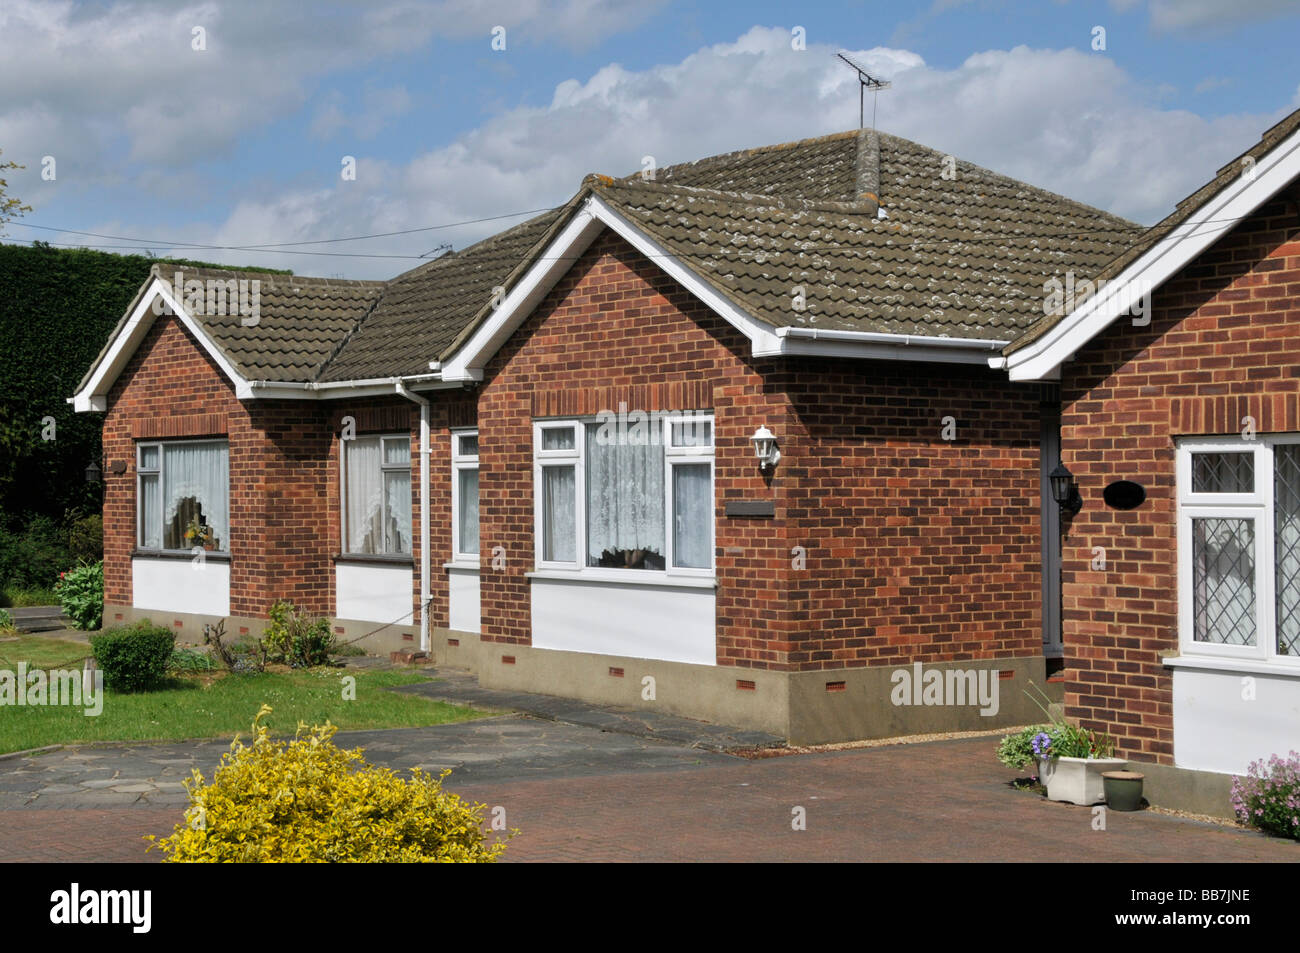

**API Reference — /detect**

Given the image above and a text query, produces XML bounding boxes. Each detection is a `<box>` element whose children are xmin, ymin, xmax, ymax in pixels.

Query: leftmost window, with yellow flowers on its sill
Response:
<box><xmin>135</xmin><ymin>439</ymin><xmax>230</xmax><ymax>553</ymax></box>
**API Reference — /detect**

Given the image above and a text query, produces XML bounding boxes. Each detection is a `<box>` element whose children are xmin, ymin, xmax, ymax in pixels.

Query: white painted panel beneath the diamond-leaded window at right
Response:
<box><xmin>1174</xmin><ymin>668</ymin><xmax>1300</xmax><ymax>775</ymax></box>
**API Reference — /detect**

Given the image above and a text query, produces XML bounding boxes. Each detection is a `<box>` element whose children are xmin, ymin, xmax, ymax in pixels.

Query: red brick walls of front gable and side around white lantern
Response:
<box><xmin>478</xmin><ymin>233</ymin><xmax>1041</xmax><ymax>670</ymax></box>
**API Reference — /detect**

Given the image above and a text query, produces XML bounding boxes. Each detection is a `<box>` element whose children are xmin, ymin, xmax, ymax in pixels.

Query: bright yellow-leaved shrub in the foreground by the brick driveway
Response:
<box><xmin>148</xmin><ymin>705</ymin><xmax>506</xmax><ymax>863</ymax></box>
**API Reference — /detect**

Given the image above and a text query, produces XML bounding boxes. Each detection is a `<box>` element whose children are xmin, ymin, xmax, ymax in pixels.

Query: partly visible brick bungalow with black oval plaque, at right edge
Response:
<box><xmin>1004</xmin><ymin>105</ymin><xmax>1300</xmax><ymax>809</ymax></box>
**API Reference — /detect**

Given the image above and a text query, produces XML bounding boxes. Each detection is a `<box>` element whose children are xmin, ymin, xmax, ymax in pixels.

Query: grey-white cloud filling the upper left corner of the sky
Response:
<box><xmin>0</xmin><ymin>0</ymin><xmax>660</xmax><ymax>185</ymax></box>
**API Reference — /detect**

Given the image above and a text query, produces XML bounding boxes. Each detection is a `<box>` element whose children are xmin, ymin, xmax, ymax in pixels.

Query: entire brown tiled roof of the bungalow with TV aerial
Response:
<box><xmin>89</xmin><ymin>125</ymin><xmax>1140</xmax><ymax>382</ymax></box>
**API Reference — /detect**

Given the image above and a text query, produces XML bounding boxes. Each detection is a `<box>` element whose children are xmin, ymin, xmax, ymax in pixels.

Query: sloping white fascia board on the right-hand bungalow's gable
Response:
<box><xmin>1006</xmin><ymin>124</ymin><xmax>1300</xmax><ymax>381</ymax></box>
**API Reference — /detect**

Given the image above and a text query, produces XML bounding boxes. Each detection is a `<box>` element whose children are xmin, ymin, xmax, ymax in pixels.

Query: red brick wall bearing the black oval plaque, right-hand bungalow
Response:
<box><xmin>1062</xmin><ymin>198</ymin><xmax>1300</xmax><ymax>763</ymax></box>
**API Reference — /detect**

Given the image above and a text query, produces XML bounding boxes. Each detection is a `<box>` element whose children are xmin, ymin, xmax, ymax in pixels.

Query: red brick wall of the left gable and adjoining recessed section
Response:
<box><xmin>104</xmin><ymin>317</ymin><xmax>436</xmax><ymax>624</ymax></box>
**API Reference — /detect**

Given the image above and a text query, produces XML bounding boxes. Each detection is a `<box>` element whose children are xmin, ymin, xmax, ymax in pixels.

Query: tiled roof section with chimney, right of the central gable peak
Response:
<box><xmin>597</xmin><ymin>124</ymin><xmax>1139</xmax><ymax>341</ymax></box>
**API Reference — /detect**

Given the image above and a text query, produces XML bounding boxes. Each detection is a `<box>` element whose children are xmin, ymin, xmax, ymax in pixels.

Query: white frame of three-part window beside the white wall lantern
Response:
<box><xmin>533</xmin><ymin>411</ymin><xmax>718</xmax><ymax>582</ymax></box>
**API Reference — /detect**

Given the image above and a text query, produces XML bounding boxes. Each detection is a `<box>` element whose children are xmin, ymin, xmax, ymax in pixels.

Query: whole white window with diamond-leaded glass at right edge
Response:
<box><xmin>1177</xmin><ymin>434</ymin><xmax>1300</xmax><ymax>667</ymax></box>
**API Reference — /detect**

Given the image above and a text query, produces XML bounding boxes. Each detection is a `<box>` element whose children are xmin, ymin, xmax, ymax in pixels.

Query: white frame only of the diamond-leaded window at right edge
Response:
<box><xmin>1175</xmin><ymin>434</ymin><xmax>1300</xmax><ymax>670</ymax></box>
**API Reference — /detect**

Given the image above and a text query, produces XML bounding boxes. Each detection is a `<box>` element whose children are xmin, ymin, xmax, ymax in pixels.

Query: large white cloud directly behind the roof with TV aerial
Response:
<box><xmin>25</xmin><ymin>27</ymin><xmax>1282</xmax><ymax>277</ymax></box>
